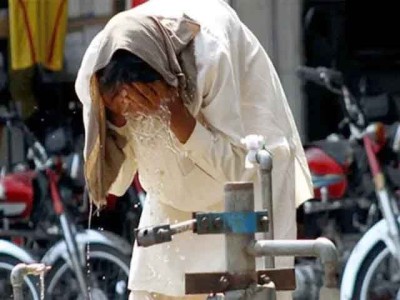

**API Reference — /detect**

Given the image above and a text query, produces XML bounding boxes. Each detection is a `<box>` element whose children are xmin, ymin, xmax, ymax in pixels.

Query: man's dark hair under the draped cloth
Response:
<box><xmin>96</xmin><ymin>49</ymin><xmax>162</xmax><ymax>95</ymax></box>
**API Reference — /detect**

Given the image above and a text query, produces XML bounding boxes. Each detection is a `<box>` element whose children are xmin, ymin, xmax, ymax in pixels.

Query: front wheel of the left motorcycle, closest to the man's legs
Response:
<box><xmin>46</xmin><ymin>244</ymin><xmax>130</xmax><ymax>300</ymax></box>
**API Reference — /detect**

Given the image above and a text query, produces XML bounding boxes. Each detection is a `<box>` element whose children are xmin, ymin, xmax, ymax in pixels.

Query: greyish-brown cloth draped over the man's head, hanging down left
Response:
<box><xmin>81</xmin><ymin>9</ymin><xmax>200</xmax><ymax>208</ymax></box>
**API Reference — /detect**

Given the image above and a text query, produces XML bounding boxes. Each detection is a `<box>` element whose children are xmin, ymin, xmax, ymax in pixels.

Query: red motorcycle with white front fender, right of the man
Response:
<box><xmin>295</xmin><ymin>67</ymin><xmax>400</xmax><ymax>299</ymax></box>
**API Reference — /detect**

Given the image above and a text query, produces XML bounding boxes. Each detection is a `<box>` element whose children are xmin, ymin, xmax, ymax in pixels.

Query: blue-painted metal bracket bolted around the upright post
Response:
<box><xmin>193</xmin><ymin>210</ymin><xmax>269</xmax><ymax>234</ymax></box>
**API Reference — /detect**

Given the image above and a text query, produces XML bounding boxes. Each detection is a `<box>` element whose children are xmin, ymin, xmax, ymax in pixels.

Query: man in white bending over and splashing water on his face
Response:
<box><xmin>76</xmin><ymin>0</ymin><xmax>312</xmax><ymax>299</ymax></box>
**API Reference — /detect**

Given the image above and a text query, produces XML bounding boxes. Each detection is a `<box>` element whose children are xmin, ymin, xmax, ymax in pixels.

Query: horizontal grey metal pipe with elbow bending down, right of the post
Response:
<box><xmin>247</xmin><ymin>238</ymin><xmax>338</xmax><ymax>288</ymax></box>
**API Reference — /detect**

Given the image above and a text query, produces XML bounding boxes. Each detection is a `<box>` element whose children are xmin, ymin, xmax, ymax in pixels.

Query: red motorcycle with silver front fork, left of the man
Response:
<box><xmin>0</xmin><ymin>109</ymin><xmax>133</xmax><ymax>299</ymax></box>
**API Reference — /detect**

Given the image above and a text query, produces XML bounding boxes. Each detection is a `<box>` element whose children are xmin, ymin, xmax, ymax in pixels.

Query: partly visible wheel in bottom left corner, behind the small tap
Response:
<box><xmin>0</xmin><ymin>254</ymin><xmax>39</xmax><ymax>300</ymax></box>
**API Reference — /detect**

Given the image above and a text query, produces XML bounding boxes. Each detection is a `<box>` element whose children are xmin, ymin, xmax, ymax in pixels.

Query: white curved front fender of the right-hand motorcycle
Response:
<box><xmin>340</xmin><ymin>219</ymin><xmax>400</xmax><ymax>300</ymax></box>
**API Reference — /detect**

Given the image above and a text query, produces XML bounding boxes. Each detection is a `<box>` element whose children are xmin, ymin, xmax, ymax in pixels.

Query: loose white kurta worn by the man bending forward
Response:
<box><xmin>76</xmin><ymin>0</ymin><xmax>312</xmax><ymax>296</ymax></box>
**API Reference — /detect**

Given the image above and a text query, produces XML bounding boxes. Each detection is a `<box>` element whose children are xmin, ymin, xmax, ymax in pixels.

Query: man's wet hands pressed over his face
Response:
<box><xmin>103</xmin><ymin>81</ymin><xmax>173</xmax><ymax>116</ymax></box>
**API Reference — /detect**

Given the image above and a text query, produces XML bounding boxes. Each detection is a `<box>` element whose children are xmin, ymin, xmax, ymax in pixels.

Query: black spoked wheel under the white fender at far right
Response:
<box><xmin>352</xmin><ymin>241</ymin><xmax>400</xmax><ymax>300</ymax></box>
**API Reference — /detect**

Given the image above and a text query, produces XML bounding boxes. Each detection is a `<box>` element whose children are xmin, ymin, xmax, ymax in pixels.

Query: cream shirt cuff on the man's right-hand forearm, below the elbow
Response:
<box><xmin>183</xmin><ymin>121</ymin><xmax>214</xmax><ymax>155</ymax></box>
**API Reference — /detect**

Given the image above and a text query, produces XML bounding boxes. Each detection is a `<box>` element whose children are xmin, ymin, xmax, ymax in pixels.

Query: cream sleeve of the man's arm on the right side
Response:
<box><xmin>183</xmin><ymin>43</ymin><xmax>255</xmax><ymax>183</ymax></box>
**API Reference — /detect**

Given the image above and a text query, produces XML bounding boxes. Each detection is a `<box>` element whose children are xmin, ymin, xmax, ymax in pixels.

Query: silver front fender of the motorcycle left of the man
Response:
<box><xmin>41</xmin><ymin>229</ymin><xmax>132</xmax><ymax>266</ymax></box>
